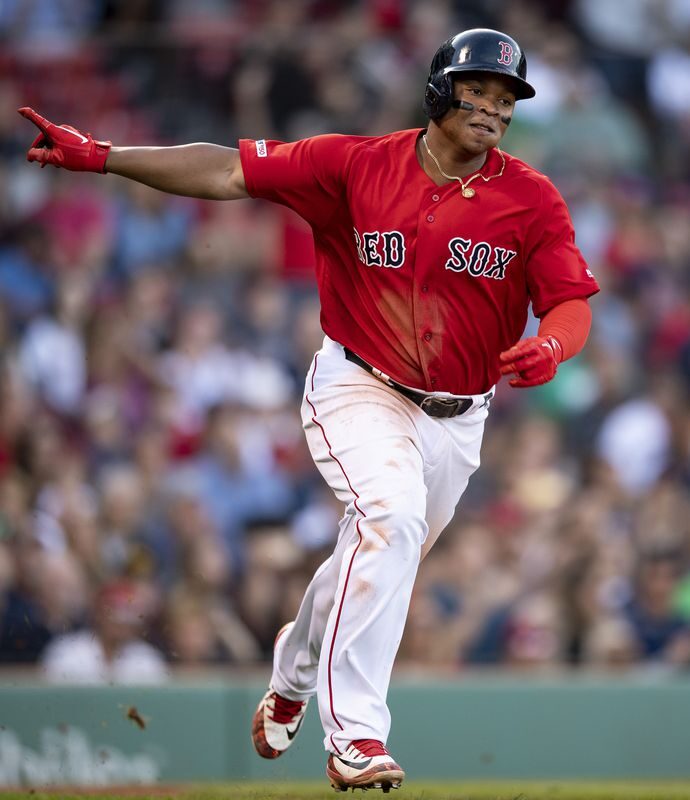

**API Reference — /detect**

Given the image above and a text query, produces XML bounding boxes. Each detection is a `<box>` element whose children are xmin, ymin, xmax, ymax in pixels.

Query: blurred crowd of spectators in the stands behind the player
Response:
<box><xmin>0</xmin><ymin>0</ymin><xmax>690</xmax><ymax>682</ymax></box>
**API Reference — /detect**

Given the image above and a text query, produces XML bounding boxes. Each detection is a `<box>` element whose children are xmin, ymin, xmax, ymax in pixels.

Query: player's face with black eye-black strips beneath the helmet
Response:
<box><xmin>444</xmin><ymin>73</ymin><xmax>515</xmax><ymax>153</ymax></box>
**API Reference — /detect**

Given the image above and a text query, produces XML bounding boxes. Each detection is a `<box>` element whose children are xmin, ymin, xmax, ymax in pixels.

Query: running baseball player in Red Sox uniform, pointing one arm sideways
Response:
<box><xmin>20</xmin><ymin>29</ymin><xmax>598</xmax><ymax>792</ymax></box>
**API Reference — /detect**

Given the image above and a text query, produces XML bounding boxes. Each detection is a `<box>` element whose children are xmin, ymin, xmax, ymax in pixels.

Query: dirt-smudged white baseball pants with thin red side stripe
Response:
<box><xmin>271</xmin><ymin>337</ymin><xmax>488</xmax><ymax>753</ymax></box>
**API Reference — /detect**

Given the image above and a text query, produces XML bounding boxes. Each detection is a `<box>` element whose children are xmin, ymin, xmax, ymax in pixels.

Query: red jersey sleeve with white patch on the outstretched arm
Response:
<box><xmin>239</xmin><ymin>134</ymin><xmax>354</xmax><ymax>228</ymax></box>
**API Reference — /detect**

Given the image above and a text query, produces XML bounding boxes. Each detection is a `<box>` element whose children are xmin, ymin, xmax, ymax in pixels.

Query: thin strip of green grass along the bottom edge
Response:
<box><xmin>6</xmin><ymin>780</ymin><xmax>690</xmax><ymax>800</ymax></box>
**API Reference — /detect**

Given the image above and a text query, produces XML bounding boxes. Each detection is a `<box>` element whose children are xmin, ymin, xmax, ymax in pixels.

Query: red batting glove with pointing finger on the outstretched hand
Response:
<box><xmin>18</xmin><ymin>107</ymin><xmax>112</xmax><ymax>172</ymax></box>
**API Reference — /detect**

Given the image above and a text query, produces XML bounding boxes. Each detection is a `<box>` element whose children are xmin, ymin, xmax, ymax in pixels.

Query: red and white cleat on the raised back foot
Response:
<box><xmin>252</xmin><ymin>622</ymin><xmax>309</xmax><ymax>758</ymax></box>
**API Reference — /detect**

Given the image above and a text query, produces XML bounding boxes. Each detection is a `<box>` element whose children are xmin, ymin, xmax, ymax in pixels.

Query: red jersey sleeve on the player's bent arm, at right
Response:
<box><xmin>525</xmin><ymin>180</ymin><xmax>599</xmax><ymax>317</ymax></box>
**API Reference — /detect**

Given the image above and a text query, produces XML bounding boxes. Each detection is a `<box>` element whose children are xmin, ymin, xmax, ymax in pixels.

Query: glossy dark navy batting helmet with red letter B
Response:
<box><xmin>424</xmin><ymin>28</ymin><xmax>536</xmax><ymax>119</ymax></box>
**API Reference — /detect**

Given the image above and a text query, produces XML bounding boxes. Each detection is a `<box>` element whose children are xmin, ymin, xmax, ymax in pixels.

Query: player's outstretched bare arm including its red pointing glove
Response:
<box><xmin>19</xmin><ymin>108</ymin><xmax>249</xmax><ymax>200</ymax></box>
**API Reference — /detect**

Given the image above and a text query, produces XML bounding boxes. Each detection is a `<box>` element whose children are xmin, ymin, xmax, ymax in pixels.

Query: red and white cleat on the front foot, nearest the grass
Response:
<box><xmin>326</xmin><ymin>739</ymin><xmax>405</xmax><ymax>794</ymax></box>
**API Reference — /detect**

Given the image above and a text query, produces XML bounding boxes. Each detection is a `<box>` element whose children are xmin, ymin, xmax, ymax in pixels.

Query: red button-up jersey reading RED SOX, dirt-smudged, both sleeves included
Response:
<box><xmin>240</xmin><ymin>129</ymin><xmax>599</xmax><ymax>395</ymax></box>
